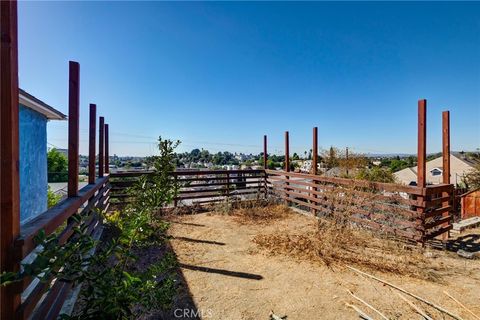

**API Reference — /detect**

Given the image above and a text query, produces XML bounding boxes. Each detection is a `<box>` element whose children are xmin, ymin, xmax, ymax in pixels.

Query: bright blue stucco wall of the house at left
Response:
<box><xmin>19</xmin><ymin>105</ymin><xmax>48</xmax><ymax>223</ymax></box>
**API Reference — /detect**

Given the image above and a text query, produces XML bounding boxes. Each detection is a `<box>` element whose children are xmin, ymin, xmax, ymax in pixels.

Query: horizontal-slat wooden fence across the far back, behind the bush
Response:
<box><xmin>110</xmin><ymin>169</ymin><xmax>266</xmax><ymax>206</ymax></box>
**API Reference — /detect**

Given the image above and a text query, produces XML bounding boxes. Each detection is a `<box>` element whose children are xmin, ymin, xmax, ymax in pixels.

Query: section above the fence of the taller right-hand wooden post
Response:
<box><xmin>417</xmin><ymin>99</ymin><xmax>427</xmax><ymax>188</ymax></box>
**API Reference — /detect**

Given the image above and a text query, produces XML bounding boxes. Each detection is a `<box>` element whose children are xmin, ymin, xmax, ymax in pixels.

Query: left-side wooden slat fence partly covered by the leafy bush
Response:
<box><xmin>14</xmin><ymin>176</ymin><xmax>110</xmax><ymax>319</ymax></box>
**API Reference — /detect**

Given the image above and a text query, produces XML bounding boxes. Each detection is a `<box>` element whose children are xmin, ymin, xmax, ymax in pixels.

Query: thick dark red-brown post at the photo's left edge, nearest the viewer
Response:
<box><xmin>0</xmin><ymin>1</ymin><xmax>20</xmax><ymax>320</ymax></box>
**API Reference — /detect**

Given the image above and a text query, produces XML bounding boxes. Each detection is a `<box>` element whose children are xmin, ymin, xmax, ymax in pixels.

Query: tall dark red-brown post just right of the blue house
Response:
<box><xmin>68</xmin><ymin>61</ymin><xmax>80</xmax><ymax>197</ymax></box>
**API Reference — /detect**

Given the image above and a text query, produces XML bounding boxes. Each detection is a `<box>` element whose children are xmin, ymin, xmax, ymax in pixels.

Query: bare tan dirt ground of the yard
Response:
<box><xmin>170</xmin><ymin>209</ymin><xmax>480</xmax><ymax>320</ymax></box>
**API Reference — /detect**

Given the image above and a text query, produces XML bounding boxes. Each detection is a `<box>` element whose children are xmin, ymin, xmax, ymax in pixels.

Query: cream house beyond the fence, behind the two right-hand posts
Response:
<box><xmin>394</xmin><ymin>153</ymin><xmax>475</xmax><ymax>186</ymax></box>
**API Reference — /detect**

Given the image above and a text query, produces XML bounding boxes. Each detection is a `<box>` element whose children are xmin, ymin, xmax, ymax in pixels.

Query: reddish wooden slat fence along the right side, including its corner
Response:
<box><xmin>266</xmin><ymin>170</ymin><xmax>453</xmax><ymax>242</ymax></box>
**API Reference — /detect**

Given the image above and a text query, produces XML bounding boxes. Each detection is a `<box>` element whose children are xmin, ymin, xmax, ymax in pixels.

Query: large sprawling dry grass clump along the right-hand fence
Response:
<box><xmin>253</xmin><ymin>221</ymin><xmax>442</xmax><ymax>281</ymax></box>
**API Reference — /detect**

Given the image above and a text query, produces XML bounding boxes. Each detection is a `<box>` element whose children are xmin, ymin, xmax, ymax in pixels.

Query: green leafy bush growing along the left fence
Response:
<box><xmin>0</xmin><ymin>137</ymin><xmax>179</xmax><ymax>319</ymax></box>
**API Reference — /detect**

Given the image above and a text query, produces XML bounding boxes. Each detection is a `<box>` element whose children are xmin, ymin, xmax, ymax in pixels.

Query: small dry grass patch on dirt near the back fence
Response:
<box><xmin>232</xmin><ymin>204</ymin><xmax>291</xmax><ymax>224</ymax></box>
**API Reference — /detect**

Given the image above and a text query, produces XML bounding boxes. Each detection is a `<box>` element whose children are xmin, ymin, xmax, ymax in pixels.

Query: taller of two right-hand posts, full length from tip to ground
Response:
<box><xmin>417</xmin><ymin>99</ymin><xmax>427</xmax><ymax>241</ymax></box>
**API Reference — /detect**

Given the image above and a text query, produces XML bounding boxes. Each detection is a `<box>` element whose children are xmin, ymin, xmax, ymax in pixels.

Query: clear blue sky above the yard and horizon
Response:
<box><xmin>19</xmin><ymin>2</ymin><xmax>480</xmax><ymax>155</ymax></box>
